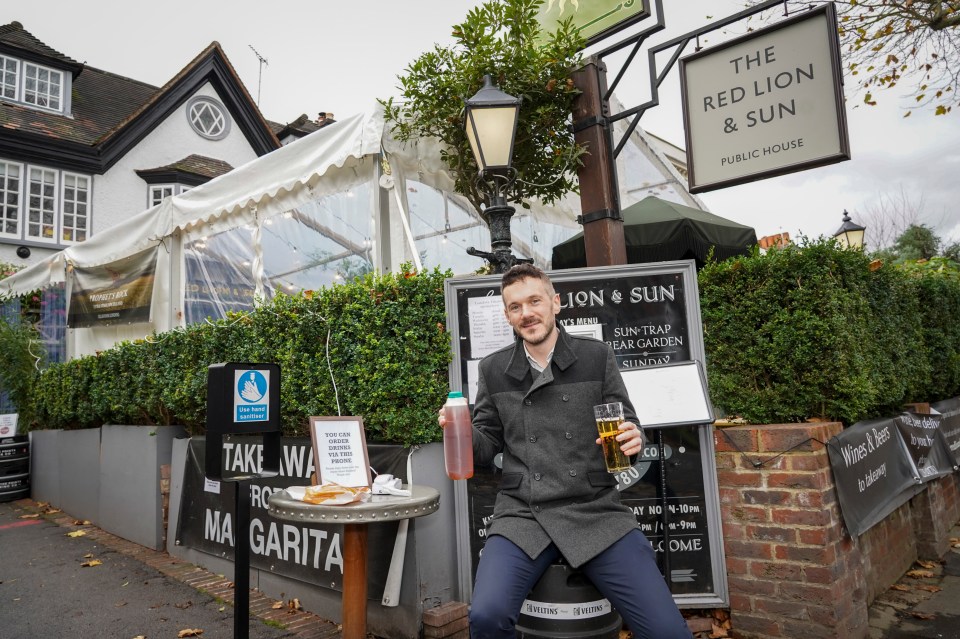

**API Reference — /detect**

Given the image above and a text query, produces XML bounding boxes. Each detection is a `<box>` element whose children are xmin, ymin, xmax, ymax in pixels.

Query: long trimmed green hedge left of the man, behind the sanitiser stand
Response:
<box><xmin>26</xmin><ymin>269</ymin><xmax>450</xmax><ymax>445</ymax></box>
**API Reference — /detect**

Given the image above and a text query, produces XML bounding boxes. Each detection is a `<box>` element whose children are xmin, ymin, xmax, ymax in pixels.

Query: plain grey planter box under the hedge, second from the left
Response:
<box><xmin>97</xmin><ymin>426</ymin><xmax>186</xmax><ymax>550</ymax></box>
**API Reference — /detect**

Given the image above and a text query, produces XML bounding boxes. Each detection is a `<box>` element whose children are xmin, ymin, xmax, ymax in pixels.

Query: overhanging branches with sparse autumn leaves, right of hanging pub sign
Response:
<box><xmin>748</xmin><ymin>0</ymin><xmax>960</xmax><ymax>117</ymax></box>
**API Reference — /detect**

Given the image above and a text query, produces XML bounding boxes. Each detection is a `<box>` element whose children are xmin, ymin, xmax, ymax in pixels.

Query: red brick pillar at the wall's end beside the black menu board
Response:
<box><xmin>715</xmin><ymin>423</ymin><xmax>867</xmax><ymax>639</ymax></box>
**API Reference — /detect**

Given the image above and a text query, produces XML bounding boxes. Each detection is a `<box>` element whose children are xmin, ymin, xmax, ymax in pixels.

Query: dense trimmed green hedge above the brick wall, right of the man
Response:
<box><xmin>699</xmin><ymin>239</ymin><xmax>960</xmax><ymax>424</ymax></box>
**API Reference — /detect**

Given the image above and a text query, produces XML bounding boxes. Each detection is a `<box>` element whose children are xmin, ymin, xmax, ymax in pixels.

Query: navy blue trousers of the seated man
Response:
<box><xmin>470</xmin><ymin>530</ymin><xmax>692</xmax><ymax>639</ymax></box>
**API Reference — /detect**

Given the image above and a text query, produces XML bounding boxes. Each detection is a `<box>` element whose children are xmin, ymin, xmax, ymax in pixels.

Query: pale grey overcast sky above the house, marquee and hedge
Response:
<box><xmin>0</xmin><ymin>0</ymin><xmax>960</xmax><ymax>241</ymax></box>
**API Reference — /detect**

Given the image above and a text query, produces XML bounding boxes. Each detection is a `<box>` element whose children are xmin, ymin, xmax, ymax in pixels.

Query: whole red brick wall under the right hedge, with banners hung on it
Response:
<box><xmin>714</xmin><ymin>422</ymin><xmax>960</xmax><ymax>639</ymax></box>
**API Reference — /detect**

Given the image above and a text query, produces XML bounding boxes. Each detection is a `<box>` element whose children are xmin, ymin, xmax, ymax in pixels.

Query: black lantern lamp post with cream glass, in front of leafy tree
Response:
<box><xmin>465</xmin><ymin>75</ymin><xmax>530</xmax><ymax>273</ymax></box>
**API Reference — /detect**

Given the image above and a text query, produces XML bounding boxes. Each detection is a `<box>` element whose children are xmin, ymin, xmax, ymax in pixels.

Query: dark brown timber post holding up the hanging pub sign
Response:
<box><xmin>573</xmin><ymin>58</ymin><xmax>627</xmax><ymax>266</ymax></box>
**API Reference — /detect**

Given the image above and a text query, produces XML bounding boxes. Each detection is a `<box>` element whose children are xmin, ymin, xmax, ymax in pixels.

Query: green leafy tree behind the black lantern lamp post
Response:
<box><xmin>381</xmin><ymin>0</ymin><xmax>585</xmax><ymax>211</ymax></box>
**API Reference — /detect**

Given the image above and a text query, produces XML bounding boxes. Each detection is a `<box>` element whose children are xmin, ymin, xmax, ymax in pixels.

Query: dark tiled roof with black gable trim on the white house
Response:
<box><xmin>0</xmin><ymin>22</ymin><xmax>280</xmax><ymax>173</ymax></box>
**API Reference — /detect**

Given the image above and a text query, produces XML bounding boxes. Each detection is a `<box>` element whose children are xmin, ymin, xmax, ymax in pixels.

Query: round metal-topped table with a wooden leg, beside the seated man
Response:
<box><xmin>267</xmin><ymin>484</ymin><xmax>440</xmax><ymax>639</ymax></box>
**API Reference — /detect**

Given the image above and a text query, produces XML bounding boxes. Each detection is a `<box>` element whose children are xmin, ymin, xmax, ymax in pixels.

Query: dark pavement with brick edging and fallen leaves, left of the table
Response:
<box><xmin>0</xmin><ymin>499</ymin><xmax>341</xmax><ymax>639</ymax></box>
